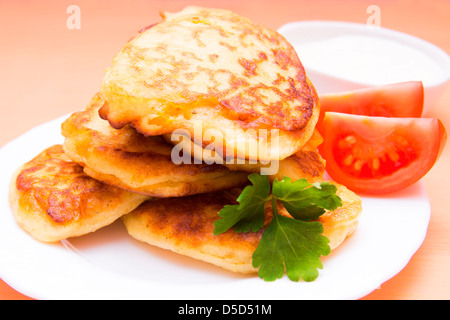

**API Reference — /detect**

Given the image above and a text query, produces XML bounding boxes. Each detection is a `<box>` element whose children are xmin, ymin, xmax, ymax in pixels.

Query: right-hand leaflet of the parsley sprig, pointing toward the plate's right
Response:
<box><xmin>272</xmin><ymin>177</ymin><xmax>342</xmax><ymax>221</ymax></box>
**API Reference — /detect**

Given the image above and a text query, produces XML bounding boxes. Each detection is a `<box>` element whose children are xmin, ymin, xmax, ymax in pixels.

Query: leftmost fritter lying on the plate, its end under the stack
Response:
<box><xmin>9</xmin><ymin>145</ymin><xmax>149</xmax><ymax>242</ymax></box>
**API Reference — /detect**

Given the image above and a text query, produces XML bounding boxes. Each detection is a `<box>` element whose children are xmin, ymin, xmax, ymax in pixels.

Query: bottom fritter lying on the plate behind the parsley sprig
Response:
<box><xmin>122</xmin><ymin>181</ymin><xmax>362</xmax><ymax>273</ymax></box>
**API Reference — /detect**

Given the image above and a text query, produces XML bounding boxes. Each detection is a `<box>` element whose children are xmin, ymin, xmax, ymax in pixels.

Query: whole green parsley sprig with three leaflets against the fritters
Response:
<box><xmin>214</xmin><ymin>173</ymin><xmax>342</xmax><ymax>281</ymax></box>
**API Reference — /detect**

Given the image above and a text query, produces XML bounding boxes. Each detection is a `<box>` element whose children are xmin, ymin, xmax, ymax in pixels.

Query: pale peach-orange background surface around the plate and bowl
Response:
<box><xmin>0</xmin><ymin>0</ymin><xmax>450</xmax><ymax>300</ymax></box>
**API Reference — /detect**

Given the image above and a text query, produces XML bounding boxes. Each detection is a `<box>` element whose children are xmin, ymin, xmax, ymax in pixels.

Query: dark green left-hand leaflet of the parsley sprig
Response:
<box><xmin>214</xmin><ymin>173</ymin><xmax>270</xmax><ymax>235</ymax></box>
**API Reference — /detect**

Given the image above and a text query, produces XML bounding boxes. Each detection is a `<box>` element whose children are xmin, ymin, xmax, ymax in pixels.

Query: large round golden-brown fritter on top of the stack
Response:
<box><xmin>100</xmin><ymin>7</ymin><xmax>319</xmax><ymax>160</ymax></box>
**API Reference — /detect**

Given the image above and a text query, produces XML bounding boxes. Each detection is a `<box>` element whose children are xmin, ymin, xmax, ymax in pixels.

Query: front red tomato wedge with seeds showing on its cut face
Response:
<box><xmin>319</xmin><ymin>112</ymin><xmax>447</xmax><ymax>195</ymax></box>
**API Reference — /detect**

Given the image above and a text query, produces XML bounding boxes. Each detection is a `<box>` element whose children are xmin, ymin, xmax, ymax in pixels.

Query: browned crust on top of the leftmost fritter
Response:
<box><xmin>16</xmin><ymin>145</ymin><xmax>122</xmax><ymax>223</ymax></box>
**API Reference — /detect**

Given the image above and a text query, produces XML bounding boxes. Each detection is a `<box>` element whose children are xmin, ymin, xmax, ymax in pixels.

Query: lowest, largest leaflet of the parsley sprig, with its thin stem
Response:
<box><xmin>252</xmin><ymin>199</ymin><xmax>330</xmax><ymax>281</ymax></box>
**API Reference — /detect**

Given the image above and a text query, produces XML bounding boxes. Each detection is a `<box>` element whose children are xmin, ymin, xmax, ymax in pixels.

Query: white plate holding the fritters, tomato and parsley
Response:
<box><xmin>0</xmin><ymin>117</ymin><xmax>430</xmax><ymax>300</ymax></box>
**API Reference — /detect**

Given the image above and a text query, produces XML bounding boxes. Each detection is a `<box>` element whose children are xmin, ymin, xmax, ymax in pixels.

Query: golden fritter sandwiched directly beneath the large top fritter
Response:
<box><xmin>62</xmin><ymin>95</ymin><xmax>248</xmax><ymax>197</ymax></box>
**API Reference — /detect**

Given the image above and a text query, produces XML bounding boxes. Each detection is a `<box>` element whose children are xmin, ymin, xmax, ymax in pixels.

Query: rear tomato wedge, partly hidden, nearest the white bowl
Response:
<box><xmin>319</xmin><ymin>81</ymin><xmax>424</xmax><ymax>124</ymax></box>
